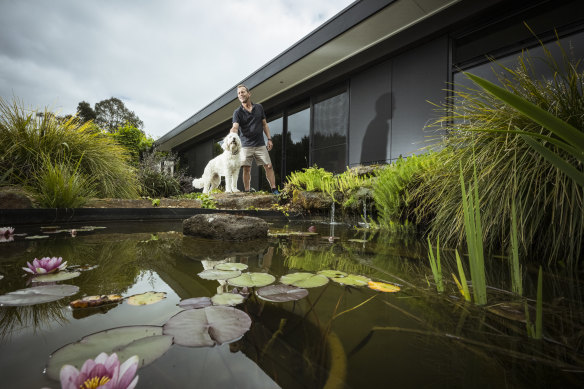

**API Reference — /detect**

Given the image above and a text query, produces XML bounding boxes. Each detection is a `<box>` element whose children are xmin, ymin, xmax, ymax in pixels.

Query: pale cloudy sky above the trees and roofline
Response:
<box><xmin>0</xmin><ymin>0</ymin><xmax>353</xmax><ymax>139</ymax></box>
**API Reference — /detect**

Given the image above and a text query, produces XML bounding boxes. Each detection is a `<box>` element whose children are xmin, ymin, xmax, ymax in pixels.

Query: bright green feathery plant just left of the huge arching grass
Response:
<box><xmin>373</xmin><ymin>153</ymin><xmax>436</xmax><ymax>229</ymax></box>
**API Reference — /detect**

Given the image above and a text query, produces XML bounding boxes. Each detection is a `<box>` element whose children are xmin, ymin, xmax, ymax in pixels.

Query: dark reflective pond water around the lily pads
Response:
<box><xmin>0</xmin><ymin>217</ymin><xmax>584</xmax><ymax>388</ymax></box>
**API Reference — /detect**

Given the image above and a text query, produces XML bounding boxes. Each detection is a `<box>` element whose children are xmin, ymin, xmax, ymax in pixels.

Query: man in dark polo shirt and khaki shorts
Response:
<box><xmin>230</xmin><ymin>85</ymin><xmax>280</xmax><ymax>195</ymax></box>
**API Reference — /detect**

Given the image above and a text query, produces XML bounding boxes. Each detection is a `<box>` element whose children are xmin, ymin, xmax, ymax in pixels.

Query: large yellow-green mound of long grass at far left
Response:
<box><xmin>0</xmin><ymin>99</ymin><xmax>138</xmax><ymax>198</ymax></box>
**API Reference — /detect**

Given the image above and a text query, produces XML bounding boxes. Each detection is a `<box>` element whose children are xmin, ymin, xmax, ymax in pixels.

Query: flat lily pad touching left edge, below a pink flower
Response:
<box><xmin>0</xmin><ymin>285</ymin><xmax>79</xmax><ymax>307</ymax></box>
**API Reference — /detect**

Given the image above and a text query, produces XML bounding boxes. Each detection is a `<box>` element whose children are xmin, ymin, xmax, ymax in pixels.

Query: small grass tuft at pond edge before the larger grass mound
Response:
<box><xmin>33</xmin><ymin>156</ymin><xmax>96</xmax><ymax>208</ymax></box>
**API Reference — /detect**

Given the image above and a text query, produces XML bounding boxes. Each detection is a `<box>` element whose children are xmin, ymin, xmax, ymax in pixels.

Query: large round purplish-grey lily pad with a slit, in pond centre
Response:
<box><xmin>163</xmin><ymin>306</ymin><xmax>251</xmax><ymax>347</ymax></box>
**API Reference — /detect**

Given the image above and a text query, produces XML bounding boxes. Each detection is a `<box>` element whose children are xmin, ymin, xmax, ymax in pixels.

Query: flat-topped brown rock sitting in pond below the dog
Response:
<box><xmin>183</xmin><ymin>213</ymin><xmax>268</xmax><ymax>240</ymax></box>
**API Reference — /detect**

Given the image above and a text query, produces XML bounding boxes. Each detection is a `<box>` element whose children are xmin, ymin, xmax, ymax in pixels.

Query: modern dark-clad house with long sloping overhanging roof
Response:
<box><xmin>156</xmin><ymin>0</ymin><xmax>584</xmax><ymax>188</ymax></box>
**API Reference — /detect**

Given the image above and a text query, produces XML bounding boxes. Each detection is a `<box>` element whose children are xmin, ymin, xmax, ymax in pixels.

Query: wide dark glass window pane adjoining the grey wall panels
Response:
<box><xmin>312</xmin><ymin>91</ymin><xmax>349</xmax><ymax>173</ymax></box>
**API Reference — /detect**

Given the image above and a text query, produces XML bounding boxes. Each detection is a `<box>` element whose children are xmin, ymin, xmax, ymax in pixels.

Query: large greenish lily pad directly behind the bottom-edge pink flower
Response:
<box><xmin>46</xmin><ymin>325</ymin><xmax>172</xmax><ymax>380</ymax></box>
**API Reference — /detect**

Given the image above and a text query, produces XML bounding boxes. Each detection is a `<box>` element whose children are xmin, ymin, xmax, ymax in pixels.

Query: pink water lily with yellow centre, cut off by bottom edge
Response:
<box><xmin>60</xmin><ymin>353</ymin><xmax>139</xmax><ymax>389</ymax></box>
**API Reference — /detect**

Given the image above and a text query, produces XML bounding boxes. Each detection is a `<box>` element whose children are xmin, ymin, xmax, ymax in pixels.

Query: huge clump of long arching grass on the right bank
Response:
<box><xmin>413</xmin><ymin>40</ymin><xmax>584</xmax><ymax>264</ymax></box>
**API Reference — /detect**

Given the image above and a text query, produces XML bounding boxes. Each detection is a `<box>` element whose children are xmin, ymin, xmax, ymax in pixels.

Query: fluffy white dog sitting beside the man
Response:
<box><xmin>193</xmin><ymin>132</ymin><xmax>241</xmax><ymax>193</ymax></box>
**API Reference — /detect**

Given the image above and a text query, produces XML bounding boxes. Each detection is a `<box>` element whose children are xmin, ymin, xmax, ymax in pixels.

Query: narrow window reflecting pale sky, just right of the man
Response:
<box><xmin>283</xmin><ymin>104</ymin><xmax>310</xmax><ymax>179</ymax></box>
